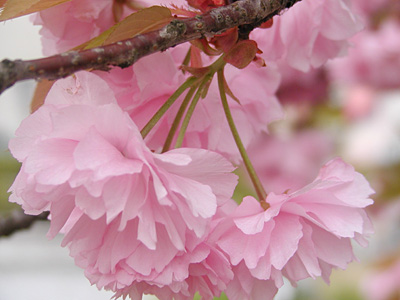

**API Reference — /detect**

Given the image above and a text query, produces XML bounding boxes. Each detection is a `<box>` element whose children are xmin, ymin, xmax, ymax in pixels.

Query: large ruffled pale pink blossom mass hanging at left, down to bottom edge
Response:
<box><xmin>10</xmin><ymin>72</ymin><xmax>237</xmax><ymax>299</ymax></box>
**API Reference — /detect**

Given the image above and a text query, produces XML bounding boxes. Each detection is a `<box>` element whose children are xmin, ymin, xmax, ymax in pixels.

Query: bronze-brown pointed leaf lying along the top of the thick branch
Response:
<box><xmin>80</xmin><ymin>6</ymin><xmax>173</xmax><ymax>49</ymax></box>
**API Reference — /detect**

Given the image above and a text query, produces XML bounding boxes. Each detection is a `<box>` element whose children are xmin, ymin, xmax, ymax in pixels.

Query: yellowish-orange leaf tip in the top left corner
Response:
<box><xmin>0</xmin><ymin>0</ymin><xmax>71</xmax><ymax>21</ymax></box>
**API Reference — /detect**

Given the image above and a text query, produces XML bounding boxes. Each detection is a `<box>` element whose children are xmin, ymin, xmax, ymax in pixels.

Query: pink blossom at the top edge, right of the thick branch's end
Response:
<box><xmin>255</xmin><ymin>0</ymin><xmax>363</xmax><ymax>72</ymax></box>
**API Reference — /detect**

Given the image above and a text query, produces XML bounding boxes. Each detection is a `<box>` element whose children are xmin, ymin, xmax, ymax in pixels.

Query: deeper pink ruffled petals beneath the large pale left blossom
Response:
<box><xmin>67</xmin><ymin>216</ymin><xmax>233</xmax><ymax>300</ymax></box>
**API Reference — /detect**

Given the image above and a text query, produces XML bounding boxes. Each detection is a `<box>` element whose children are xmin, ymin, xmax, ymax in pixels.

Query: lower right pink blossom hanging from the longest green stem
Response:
<box><xmin>217</xmin><ymin>158</ymin><xmax>373</xmax><ymax>292</ymax></box>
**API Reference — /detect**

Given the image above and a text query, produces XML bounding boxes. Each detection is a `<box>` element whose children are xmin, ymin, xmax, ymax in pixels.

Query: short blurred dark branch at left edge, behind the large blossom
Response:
<box><xmin>0</xmin><ymin>209</ymin><xmax>49</xmax><ymax>237</ymax></box>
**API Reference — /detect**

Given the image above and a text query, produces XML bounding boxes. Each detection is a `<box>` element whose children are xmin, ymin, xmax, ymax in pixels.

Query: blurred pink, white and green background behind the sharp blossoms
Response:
<box><xmin>0</xmin><ymin>0</ymin><xmax>400</xmax><ymax>300</ymax></box>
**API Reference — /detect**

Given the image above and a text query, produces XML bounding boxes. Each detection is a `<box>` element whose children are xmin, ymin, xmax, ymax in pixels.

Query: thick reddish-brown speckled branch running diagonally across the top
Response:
<box><xmin>0</xmin><ymin>0</ymin><xmax>301</xmax><ymax>94</ymax></box>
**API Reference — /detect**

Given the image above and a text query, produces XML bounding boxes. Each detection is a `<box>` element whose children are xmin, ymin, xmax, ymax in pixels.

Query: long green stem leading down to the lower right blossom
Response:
<box><xmin>218</xmin><ymin>69</ymin><xmax>268</xmax><ymax>204</ymax></box>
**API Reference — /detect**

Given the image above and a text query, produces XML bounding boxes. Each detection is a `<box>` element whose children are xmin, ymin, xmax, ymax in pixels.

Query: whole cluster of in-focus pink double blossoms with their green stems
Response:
<box><xmin>9</xmin><ymin>0</ymin><xmax>373</xmax><ymax>300</ymax></box>
